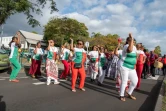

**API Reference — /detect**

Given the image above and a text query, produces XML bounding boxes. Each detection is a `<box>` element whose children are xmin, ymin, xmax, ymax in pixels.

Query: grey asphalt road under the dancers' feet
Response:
<box><xmin>0</xmin><ymin>67</ymin><xmax>163</xmax><ymax>111</ymax></box>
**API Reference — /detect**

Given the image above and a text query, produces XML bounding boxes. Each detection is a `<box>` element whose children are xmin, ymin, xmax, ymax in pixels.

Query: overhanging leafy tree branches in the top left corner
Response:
<box><xmin>0</xmin><ymin>0</ymin><xmax>58</xmax><ymax>27</ymax></box>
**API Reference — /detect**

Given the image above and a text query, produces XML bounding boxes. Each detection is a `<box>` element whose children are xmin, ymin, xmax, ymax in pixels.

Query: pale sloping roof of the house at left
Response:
<box><xmin>20</xmin><ymin>30</ymin><xmax>43</xmax><ymax>41</ymax></box>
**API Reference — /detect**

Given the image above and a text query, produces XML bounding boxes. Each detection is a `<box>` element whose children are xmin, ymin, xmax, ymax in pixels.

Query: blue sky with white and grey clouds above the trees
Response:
<box><xmin>1</xmin><ymin>0</ymin><xmax>166</xmax><ymax>54</ymax></box>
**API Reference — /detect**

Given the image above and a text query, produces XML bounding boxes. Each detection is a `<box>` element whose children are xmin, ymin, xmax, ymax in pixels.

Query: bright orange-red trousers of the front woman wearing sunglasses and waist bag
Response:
<box><xmin>71</xmin><ymin>62</ymin><xmax>86</xmax><ymax>89</ymax></box>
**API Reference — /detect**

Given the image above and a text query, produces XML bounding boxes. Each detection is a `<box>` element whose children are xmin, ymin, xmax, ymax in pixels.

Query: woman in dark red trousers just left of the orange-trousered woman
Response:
<box><xmin>60</xmin><ymin>44</ymin><xmax>70</xmax><ymax>79</ymax></box>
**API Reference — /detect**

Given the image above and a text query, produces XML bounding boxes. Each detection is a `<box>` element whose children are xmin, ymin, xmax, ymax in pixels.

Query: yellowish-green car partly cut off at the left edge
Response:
<box><xmin>0</xmin><ymin>49</ymin><xmax>10</xmax><ymax>70</ymax></box>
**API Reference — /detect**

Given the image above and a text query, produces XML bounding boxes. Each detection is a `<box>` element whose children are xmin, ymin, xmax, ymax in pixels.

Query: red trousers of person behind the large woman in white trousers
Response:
<box><xmin>136</xmin><ymin>64</ymin><xmax>144</xmax><ymax>89</ymax></box>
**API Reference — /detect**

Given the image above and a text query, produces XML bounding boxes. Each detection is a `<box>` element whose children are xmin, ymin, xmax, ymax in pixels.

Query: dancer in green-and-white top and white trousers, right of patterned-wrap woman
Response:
<box><xmin>98</xmin><ymin>47</ymin><xmax>107</xmax><ymax>86</ymax></box>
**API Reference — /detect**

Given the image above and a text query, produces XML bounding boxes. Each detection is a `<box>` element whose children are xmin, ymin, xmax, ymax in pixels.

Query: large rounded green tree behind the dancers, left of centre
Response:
<box><xmin>44</xmin><ymin>17</ymin><xmax>89</xmax><ymax>46</ymax></box>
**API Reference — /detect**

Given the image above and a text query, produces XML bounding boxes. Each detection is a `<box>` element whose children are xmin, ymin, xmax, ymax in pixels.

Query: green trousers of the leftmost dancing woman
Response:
<box><xmin>10</xmin><ymin>58</ymin><xmax>21</xmax><ymax>80</ymax></box>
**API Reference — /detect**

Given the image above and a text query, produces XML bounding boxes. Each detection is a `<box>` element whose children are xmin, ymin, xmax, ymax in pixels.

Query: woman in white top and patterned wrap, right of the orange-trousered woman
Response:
<box><xmin>88</xmin><ymin>46</ymin><xmax>99</xmax><ymax>82</ymax></box>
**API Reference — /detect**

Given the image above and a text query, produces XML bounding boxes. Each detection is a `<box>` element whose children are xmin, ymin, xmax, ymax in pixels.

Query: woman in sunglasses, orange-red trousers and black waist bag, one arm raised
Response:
<box><xmin>71</xmin><ymin>39</ymin><xmax>86</xmax><ymax>92</ymax></box>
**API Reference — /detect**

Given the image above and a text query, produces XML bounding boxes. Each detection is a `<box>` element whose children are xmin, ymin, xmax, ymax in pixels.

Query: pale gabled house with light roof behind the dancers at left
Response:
<box><xmin>15</xmin><ymin>30</ymin><xmax>46</xmax><ymax>49</ymax></box>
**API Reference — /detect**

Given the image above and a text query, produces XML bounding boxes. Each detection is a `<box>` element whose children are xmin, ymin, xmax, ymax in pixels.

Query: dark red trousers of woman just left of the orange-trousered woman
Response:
<box><xmin>60</xmin><ymin>60</ymin><xmax>70</xmax><ymax>78</ymax></box>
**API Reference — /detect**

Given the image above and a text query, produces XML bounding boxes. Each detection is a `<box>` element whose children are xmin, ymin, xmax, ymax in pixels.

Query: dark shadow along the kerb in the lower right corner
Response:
<box><xmin>138</xmin><ymin>80</ymin><xmax>162</xmax><ymax>111</ymax></box>
